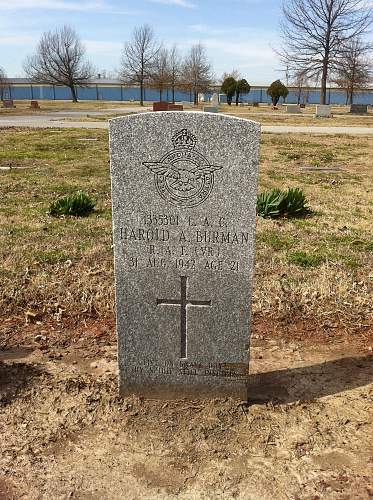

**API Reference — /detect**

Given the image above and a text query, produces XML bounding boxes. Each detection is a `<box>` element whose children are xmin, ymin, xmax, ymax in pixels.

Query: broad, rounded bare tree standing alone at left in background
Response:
<box><xmin>23</xmin><ymin>25</ymin><xmax>94</xmax><ymax>102</ymax></box>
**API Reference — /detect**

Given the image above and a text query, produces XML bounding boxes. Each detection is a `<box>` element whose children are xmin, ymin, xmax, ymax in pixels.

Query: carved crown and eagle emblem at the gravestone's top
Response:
<box><xmin>143</xmin><ymin>129</ymin><xmax>223</xmax><ymax>208</ymax></box>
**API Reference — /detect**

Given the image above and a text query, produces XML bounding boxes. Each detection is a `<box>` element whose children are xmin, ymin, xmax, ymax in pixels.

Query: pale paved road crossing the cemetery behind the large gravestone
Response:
<box><xmin>0</xmin><ymin>113</ymin><xmax>373</xmax><ymax>135</ymax></box>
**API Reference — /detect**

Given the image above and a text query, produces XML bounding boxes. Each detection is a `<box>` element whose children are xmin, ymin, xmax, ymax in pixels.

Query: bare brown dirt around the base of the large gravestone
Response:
<box><xmin>0</xmin><ymin>320</ymin><xmax>373</xmax><ymax>500</ymax></box>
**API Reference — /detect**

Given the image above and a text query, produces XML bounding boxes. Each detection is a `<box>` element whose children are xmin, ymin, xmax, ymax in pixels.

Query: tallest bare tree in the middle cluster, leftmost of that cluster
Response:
<box><xmin>120</xmin><ymin>24</ymin><xmax>161</xmax><ymax>106</ymax></box>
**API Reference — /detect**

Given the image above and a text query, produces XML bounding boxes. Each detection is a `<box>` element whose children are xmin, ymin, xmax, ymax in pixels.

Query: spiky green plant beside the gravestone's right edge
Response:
<box><xmin>257</xmin><ymin>188</ymin><xmax>309</xmax><ymax>219</ymax></box>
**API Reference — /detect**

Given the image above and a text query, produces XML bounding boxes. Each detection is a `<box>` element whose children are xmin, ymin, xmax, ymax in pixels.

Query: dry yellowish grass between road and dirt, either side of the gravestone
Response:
<box><xmin>0</xmin><ymin>129</ymin><xmax>373</xmax><ymax>323</ymax></box>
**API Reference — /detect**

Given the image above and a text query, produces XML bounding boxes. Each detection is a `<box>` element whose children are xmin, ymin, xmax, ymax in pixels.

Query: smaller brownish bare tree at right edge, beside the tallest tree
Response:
<box><xmin>334</xmin><ymin>38</ymin><xmax>373</xmax><ymax>104</ymax></box>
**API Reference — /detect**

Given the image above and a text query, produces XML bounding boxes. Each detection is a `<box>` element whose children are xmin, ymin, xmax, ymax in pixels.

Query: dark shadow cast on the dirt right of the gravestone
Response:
<box><xmin>249</xmin><ymin>356</ymin><xmax>373</xmax><ymax>403</ymax></box>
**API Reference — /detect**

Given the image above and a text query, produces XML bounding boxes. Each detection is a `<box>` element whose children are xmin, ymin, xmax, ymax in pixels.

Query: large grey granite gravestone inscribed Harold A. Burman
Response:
<box><xmin>109</xmin><ymin>111</ymin><xmax>260</xmax><ymax>400</ymax></box>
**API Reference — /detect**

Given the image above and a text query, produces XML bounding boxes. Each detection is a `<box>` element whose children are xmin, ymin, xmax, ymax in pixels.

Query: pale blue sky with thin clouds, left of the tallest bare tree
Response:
<box><xmin>0</xmin><ymin>0</ymin><xmax>283</xmax><ymax>84</ymax></box>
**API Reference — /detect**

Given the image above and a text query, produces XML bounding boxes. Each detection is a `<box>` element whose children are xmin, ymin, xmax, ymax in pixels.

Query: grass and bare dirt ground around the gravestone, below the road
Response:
<box><xmin>0</xmin><ymin>129</ymin><xmax>373</xmax><ymax>500</ymax></box>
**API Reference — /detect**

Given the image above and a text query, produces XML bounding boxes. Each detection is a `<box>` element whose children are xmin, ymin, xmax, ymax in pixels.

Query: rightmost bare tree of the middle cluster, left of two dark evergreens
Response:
<box><xmin>182</xmin><ymin>43</ymin><xmax>213</xmax><ymax>104</ymax></box>
